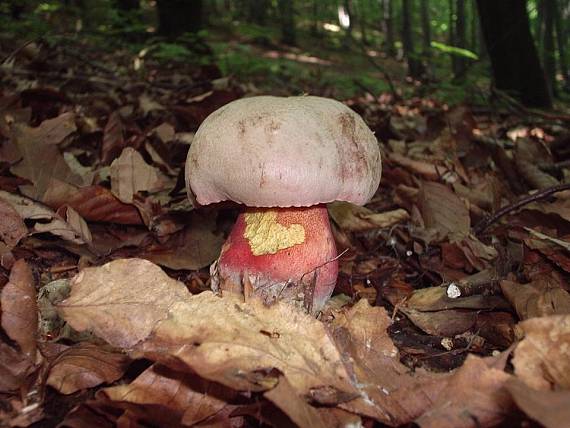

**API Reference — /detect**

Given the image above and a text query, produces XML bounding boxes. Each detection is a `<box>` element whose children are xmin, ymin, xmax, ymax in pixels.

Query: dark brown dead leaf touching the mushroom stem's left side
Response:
<box><xmin>142</xmin><ymin>212</ymin><xmax>224</xmax><ymax>270</ymax></box>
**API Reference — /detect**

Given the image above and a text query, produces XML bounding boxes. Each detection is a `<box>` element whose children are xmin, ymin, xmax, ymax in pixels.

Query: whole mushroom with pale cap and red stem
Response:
<box><xmin>186</xmin><ymin>96</ymin><xmax>381</xmax><ymax>313</ymax></box>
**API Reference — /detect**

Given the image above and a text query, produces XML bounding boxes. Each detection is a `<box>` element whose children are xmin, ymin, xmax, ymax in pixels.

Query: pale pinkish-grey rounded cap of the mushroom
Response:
<box><xmin>186</xmin><ymin>96</ymin><xmax>382</xmax><ymax>207</ymax></box>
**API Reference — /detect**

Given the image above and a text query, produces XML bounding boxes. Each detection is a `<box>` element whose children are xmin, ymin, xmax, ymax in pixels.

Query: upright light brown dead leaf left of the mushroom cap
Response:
<box><xmin>110</xmin><ymin>147</ymin><xmax>168</xmax><ymax>203</ymax></box>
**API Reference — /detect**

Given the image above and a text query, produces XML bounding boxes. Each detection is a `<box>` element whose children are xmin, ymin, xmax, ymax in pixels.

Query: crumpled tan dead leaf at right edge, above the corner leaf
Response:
<box><xmin>513</xmin><ymin>315</ymin><xmax>570</xmax><ymax>390</ymax></box>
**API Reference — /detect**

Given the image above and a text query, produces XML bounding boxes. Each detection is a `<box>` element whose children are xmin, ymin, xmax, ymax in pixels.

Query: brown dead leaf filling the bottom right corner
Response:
<box><xmin>507</xmin><ymin>379</ymin><xmax>570</xmax><ymax>428</ymax></box>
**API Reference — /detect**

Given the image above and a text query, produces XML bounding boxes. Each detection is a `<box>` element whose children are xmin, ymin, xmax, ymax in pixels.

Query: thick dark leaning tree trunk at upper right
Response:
<box><xmin>477</xmin><ymin>0</ymin><xmax>552</xmax><ymax>107</ymax></box>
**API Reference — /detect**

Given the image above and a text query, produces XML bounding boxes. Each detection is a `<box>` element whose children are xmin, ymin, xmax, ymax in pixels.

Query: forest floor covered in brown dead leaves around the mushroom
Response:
<box><xmin>0</xmin><ymin>27</ymin><xmax>570</xmax><ymax>427</ymax></box>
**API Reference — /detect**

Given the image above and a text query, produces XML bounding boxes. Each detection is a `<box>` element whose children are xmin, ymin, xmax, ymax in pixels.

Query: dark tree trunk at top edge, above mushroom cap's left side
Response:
<box><xmin>156</xmin><ymin>0</ymin><xmax>203</xmax><ymax>38</ymax></box>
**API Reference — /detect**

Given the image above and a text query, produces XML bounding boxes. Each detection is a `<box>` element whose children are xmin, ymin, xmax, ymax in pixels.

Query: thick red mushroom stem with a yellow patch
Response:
<box><xmin>211</xmin><ymin>205</ymin><xmax>338</xmax><ymax>314</ymax></box>
